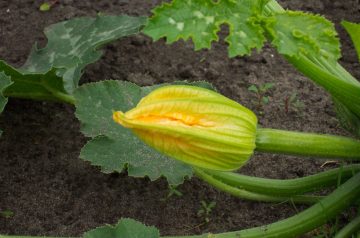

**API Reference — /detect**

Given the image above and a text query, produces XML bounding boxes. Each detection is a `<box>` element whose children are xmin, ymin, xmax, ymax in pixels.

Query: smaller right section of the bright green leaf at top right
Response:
<box><xmin>266</xmin><ymin>11</ymin><xmax>340</xmax><ymax>62</ymax></box>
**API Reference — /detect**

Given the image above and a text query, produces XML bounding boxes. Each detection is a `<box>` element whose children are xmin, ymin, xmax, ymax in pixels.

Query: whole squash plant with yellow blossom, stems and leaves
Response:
<box><xmin>0</xmin><ymin>0</ymin><xmax>360</xmax><ymax>238</ymax></box>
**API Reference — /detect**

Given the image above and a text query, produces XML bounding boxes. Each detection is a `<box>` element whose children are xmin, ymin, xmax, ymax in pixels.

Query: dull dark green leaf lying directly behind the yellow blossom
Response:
<box><xmin>74</xmin><ymin>81</ymin><xmax>219</xmax><ymax>184</ymax></box>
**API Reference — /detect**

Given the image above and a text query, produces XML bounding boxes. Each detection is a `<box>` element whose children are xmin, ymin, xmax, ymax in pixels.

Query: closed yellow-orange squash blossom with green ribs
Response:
<box><xmin>113</xmin><ymin>85</ymin><xmax>257</xmax><ymax>171</ymax></box>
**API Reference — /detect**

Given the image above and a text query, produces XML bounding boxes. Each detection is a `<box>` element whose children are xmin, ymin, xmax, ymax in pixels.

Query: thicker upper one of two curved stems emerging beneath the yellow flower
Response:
<box><xmin>196</xmin><ymin>164</ymin><xmax>360</xmax><ymax>196</ymax></box>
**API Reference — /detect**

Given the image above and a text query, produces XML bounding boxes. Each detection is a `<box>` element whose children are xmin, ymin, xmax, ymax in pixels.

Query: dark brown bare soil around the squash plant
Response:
<box><xmin>0</xmin><ymin>0</ymin><xmax>360</xmax><ymax>236</ymax></box>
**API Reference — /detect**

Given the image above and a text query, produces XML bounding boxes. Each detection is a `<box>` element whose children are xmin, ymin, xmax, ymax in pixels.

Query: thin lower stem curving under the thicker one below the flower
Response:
<box><xmin>194</xmin><ymin>168</ymin><xmax>323</xmax><ymax>204</ymax></box>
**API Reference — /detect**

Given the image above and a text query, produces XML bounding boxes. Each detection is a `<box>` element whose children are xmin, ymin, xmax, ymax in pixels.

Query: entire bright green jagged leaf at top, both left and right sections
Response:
<box><xmin>144</xmin><ymin>0</ymin><xmax>340</xmax><ymax>62</ymax></box>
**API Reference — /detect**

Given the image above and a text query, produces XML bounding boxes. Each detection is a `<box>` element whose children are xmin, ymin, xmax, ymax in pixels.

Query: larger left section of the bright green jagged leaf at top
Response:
<box><xmin>144</xmin><ymin>0</ymin><xmax>268</xmax><ymax>57</ymax></box>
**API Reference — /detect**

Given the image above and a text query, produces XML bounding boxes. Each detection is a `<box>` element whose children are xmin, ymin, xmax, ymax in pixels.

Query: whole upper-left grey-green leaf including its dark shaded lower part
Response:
<box><xmin>0</xmin><ymin>16</ymin><xmax>146</xmax><ymax>103</ymax></box>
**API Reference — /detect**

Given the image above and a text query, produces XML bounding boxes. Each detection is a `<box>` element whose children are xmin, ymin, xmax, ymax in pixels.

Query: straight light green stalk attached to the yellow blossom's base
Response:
<box><xmin>256</xmin><ymin>128</ymin><xmax>360</xmax><ymax>160</ymax></box>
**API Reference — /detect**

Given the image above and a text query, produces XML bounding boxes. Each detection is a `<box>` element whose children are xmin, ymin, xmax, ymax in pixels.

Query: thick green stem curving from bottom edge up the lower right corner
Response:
<box><xmin>163</xmin><ymin>173</ymin><xmax>360</xmax><ymax>238</ymax></box>
